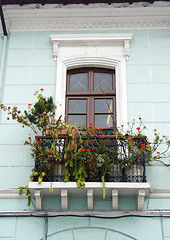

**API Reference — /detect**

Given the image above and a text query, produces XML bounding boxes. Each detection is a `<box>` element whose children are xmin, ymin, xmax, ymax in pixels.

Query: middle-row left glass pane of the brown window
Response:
<box><xmin>69</xmin><ymin>99</ymin><xmax>87</xmax><ymax>113</ymax></box>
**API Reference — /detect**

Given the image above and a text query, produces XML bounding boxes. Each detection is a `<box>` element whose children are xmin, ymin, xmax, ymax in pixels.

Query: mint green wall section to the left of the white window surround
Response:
<box><xmin>0</xmin><ymin>32</ymin><xmax>56</xmax><ymax>189</ymax></box>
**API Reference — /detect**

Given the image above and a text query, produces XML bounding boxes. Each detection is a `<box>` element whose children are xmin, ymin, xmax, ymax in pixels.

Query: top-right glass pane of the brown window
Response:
<box><xmin>94</xmin><ymin>72</ymin><xmax>113</xmax><ymax>91</ymax></box>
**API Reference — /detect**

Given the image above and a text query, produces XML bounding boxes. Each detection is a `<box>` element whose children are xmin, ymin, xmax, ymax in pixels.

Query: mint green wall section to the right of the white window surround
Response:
<box><xmin>127</xmin><ymin>30</ymin><xmax>170</xmax><ymax>191</ymax></box>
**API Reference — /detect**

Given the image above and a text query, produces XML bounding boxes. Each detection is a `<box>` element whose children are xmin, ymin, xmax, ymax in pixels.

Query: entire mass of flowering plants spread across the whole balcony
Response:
<box><xmin>0</xmin><ymin>88</ymin><xmax>170</xmax><ymax>203</ymax></box>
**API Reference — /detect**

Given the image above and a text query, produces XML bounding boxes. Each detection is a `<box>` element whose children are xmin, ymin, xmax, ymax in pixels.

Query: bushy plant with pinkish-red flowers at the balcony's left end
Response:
<box><xmin>0</xmin><ymin>88</ymin><xmax>67</xmax><ymax>202</ymax></box>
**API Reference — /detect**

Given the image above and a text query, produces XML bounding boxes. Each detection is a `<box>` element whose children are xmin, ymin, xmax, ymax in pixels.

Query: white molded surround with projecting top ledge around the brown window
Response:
<box><xmin>50</xmin><ymin>33</ymin><xmax>132</xmax><ymax>127</ymax></box>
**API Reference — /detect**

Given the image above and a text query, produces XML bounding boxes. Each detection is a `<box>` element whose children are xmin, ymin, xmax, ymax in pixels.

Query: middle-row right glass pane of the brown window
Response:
<box><xmin>95</xmin><ymin>99</ymin><xmax>113</xmax><ymax>113</ymax></box>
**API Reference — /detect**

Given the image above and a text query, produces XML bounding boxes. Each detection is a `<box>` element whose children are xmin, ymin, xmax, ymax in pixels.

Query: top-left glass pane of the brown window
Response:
<box><xmin>69</xmin><ymin>73</ymin><xmax>88</xmax><ymax>91</ymax></box>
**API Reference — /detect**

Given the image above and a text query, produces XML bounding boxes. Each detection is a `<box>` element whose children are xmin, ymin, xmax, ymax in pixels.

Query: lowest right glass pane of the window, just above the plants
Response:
<box><xmin>95</xmin><ymin>114</ymin><xmax>113</xmax><ymax>128</ymax></box>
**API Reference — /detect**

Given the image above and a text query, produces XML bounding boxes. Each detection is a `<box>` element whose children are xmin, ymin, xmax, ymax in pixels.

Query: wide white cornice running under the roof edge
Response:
<box><xmin>0</xmin><ymin>4</ymin><xmax>170</xmax><ymax>32</ymax></box>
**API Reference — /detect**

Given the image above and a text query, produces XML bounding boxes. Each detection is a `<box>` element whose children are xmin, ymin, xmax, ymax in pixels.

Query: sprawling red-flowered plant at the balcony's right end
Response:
<box><xmin>116</xmin><ymin>117</ymin><xmax>170</xmax><ymax>166</ymax></box>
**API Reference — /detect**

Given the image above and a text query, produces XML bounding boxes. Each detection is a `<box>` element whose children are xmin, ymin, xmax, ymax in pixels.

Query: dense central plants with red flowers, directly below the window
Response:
<box><xmin>64</xmin><ymin>124</ymin><xmax>113</xmax><ymax>192</ymax></box>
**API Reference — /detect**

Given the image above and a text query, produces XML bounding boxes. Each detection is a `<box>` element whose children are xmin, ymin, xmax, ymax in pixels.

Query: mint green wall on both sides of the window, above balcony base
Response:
<box><xmin>0</xmin><ymin>30</ymin><xmax>170</xmax><ymax>188</ymax></box>
